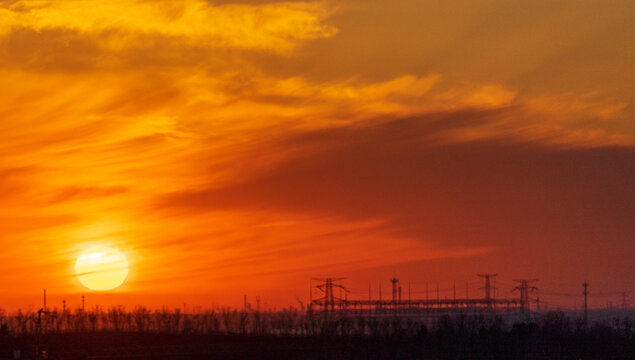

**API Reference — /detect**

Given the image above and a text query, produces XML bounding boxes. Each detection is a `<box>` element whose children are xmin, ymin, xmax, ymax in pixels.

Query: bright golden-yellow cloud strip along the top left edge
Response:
<box><xmin>0</xmin><ymin>0</ymin><xmax>337</xmax><ymax>51</ymax></box>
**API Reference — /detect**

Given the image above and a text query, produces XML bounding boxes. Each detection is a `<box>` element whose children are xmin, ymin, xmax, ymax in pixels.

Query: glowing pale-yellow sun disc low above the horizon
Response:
<box><xmin>75</xmin><ymin>245</ymin><xmax>128</xmax><ymax>291</ymax></box>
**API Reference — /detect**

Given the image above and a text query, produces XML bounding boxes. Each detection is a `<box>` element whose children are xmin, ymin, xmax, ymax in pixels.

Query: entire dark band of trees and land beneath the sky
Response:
<box><xmin>0</xmin><ymin>308</ymin><xmax>635</xmax><ymax>360</ymax></box>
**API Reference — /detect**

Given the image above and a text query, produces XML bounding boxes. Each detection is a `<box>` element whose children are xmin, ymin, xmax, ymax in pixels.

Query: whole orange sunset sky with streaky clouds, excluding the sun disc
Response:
<box><xmin>0</xmin><ymin>0</ymin><xmax>635</xmax><ymax>310</ymax></box>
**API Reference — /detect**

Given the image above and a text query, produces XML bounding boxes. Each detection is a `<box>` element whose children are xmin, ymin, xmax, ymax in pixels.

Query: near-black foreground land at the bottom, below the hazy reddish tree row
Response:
<box><xmin>0</xmin><ymin>314</ymin><xmax>635</xmax><ymax>360</ymax></box>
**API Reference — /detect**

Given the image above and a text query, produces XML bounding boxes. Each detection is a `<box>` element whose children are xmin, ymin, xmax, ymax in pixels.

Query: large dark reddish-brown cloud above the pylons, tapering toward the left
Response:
<box><xmin>157</xmin><ymin>109</ymin><xmax>635</xmax><ymax>253</ymax></box>
